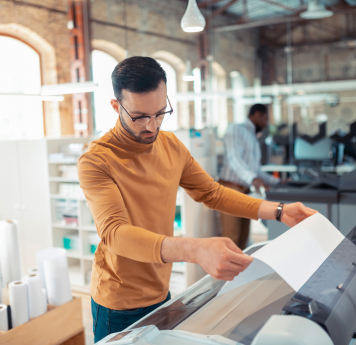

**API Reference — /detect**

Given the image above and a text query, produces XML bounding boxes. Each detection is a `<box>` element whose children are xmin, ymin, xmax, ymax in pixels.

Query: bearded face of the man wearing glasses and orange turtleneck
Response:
<box><xmin>111</xmin><ymin>80</ymin><xmax>167</xmax><ymax>144</ymax></box>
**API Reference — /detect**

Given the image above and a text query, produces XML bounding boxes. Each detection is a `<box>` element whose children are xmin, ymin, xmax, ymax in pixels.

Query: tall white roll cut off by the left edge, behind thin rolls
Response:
<box><xmin>0</xmin><ymin>220</ymin><xmax>21</xmax><ymax>287</ymax></box>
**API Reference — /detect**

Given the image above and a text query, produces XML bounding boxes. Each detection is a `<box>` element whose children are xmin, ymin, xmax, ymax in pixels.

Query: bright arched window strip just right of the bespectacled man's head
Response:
<box><xmin>156</xmin><ymin>59</ymin><xmax>178</xmax><ymax>131</ymax></box>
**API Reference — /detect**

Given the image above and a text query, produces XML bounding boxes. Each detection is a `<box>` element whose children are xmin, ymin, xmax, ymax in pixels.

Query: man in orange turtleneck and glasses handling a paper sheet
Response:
<box><xmin>78</xmin><ymin>57</ymin><xmax>315</xmax><ymax>342</ymax></box>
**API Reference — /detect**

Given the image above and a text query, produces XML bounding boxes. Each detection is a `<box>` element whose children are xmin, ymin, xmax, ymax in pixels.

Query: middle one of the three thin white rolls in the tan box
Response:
<box><xmin>9</xmin><ymin>280</ymin><xmax>30</xmax><ymax>328</ymax></box>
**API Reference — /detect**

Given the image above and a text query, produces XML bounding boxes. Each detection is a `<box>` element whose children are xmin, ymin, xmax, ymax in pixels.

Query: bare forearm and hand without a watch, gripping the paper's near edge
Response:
<box><xmin>161</xmin><ymin>237</ymin><xmax>253</xmax><ymax>281</ymax></box>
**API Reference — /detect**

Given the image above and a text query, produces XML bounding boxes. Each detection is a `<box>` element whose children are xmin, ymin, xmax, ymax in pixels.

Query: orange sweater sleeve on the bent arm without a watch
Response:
<box><xmin>78</xmin><ymin>153</ymin><xmax>165</xmax><ymax>263</ymax></box>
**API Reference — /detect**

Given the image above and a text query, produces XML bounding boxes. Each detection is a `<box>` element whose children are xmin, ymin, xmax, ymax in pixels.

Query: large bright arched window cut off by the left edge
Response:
<box><xmin>0</xmin><ymin>36</ymin><xmax>44</xmax><ymax>140</ymax></box>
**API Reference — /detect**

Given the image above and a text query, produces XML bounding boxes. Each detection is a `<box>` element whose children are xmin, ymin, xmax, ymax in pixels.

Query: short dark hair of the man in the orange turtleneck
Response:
<box><xmin>111</xmin><ymin>56</ymin><xmax>167</xmax><ymax>101</ymax></box>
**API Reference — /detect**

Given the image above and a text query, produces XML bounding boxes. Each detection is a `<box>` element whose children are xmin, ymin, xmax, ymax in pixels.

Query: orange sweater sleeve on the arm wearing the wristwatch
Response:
<box><xmin>180</xmin><ymin>144</ymin><xmax>263</xmax><ymax>219</ymax></box>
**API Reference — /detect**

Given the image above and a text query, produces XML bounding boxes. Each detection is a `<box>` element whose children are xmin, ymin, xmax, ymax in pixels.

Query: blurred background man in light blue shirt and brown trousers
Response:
<box><xmin>219</xmin><ymin>104</ymin><xmax>279</xmax><ymax>249</ymax></box>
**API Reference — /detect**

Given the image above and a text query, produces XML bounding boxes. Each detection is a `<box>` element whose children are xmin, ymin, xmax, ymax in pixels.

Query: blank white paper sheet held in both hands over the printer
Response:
<box><xmin>219</xmin><ymin>213</ymin><xmax>345</xmax><ymax>295</ymax></box>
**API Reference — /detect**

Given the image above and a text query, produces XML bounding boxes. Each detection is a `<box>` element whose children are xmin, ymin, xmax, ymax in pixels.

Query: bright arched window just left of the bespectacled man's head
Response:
<box><xmin>92</xmin><ymin>50</ymin><xmax>118</xmax><ymax>134</ymax></box>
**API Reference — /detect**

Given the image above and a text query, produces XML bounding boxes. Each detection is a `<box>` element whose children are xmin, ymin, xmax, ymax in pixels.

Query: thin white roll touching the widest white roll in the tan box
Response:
<box><xmin>22</xmin><ymin>273</ymin><xmax>46</xmax><ymax>319</ymax></box>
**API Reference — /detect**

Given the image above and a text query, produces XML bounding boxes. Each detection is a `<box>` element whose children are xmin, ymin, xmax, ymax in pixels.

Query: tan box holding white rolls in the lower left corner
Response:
<box><xmin>0</xmin><ymin>297</ymin><xmax>85</xmax><ymax>345</ymax></box>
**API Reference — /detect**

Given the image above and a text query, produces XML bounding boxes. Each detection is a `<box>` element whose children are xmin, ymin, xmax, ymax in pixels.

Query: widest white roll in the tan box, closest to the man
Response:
<box><xmin>37</xmin><ymin>248</ymin><xmax>72</xmax><ymax>306</ymax></box>
